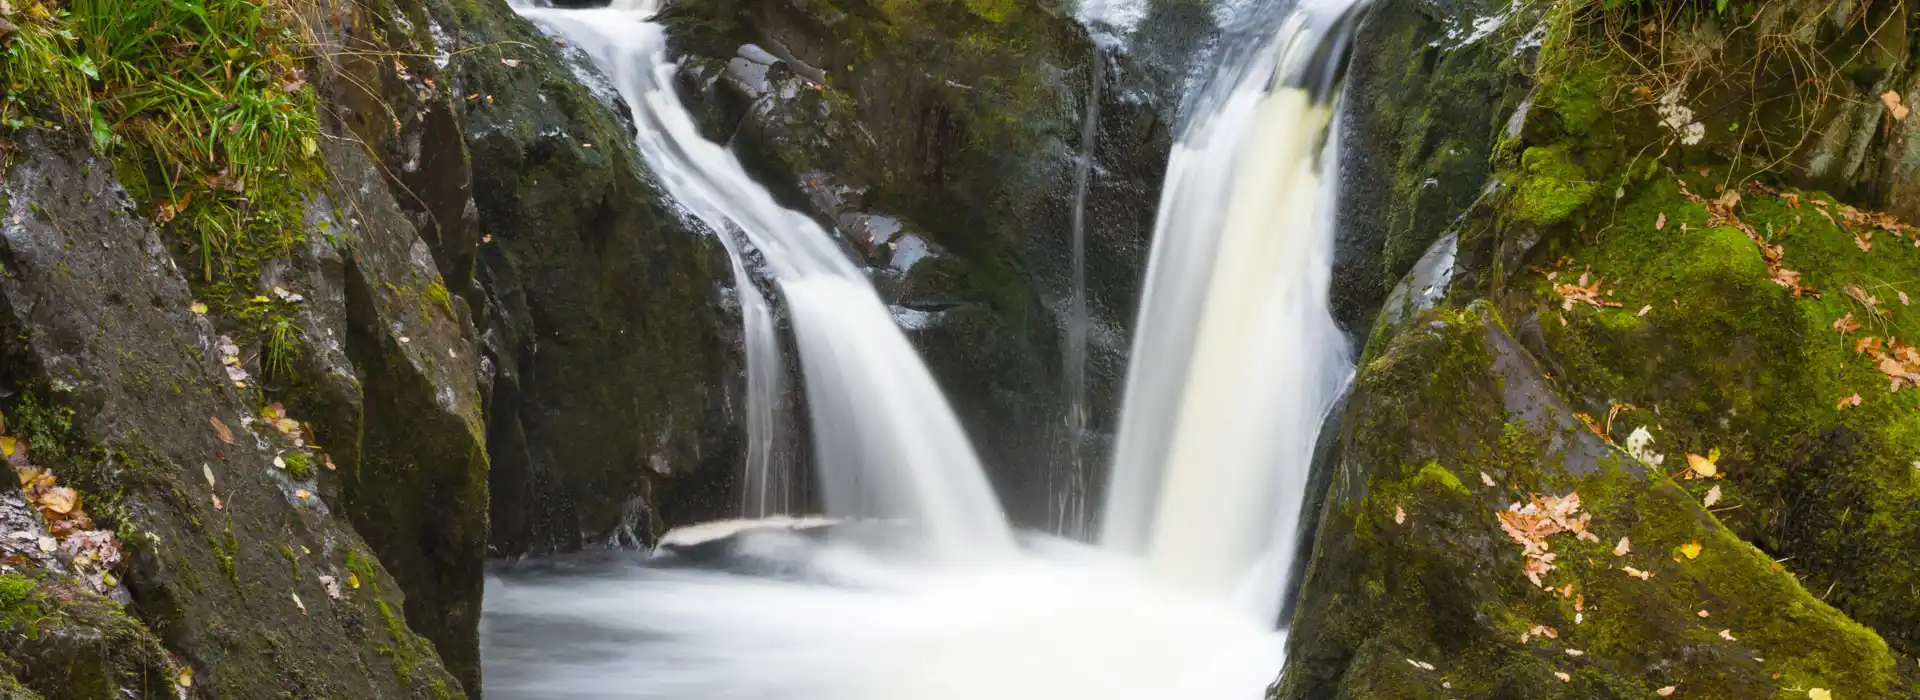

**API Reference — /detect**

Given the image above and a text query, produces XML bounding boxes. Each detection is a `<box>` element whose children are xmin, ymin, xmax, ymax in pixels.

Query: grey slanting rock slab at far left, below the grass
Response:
<box><xmin>0</xmin><ymin>136</ymin><xmax>460</xmax><ymax>698</ymax></box>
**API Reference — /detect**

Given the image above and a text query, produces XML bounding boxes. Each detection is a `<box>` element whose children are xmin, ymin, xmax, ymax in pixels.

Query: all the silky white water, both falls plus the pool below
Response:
<box><xmin>482</xmin><ymin>0</ymin><xmax>1354</xmax><ymax>700</ymax></box>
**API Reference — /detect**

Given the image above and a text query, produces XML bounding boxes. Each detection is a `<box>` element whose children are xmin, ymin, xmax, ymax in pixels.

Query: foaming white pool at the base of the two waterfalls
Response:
<box><xmin>484</xmin><ymin>529</ymin><xmax>1284</xmax><ymax>700</ymax></box>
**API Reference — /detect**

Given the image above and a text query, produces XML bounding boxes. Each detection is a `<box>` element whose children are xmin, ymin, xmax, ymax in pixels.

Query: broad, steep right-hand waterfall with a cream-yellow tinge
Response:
<box><xmin>1102</xmin><ymin>0</ymin><xmax>1356</xmax><ymax>619</ymax></box>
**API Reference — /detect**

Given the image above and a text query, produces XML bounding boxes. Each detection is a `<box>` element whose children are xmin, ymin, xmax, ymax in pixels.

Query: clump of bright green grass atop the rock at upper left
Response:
<box><xmin>0</xmin><ymin>0</ymin><xmax>319</xmax><ymax>304</ymax></box>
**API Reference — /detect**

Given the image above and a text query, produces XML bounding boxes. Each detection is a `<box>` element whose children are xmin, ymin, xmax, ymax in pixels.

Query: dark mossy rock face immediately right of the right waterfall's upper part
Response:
<box><xmin>1332</xmin><ymin>0</ymin><xmax>1540</xmax><ymax>338</ymax></box>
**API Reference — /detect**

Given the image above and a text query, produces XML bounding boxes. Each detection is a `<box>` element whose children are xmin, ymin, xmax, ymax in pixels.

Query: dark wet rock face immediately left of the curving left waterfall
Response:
<box><xmin>348</xmin><ymin>2</ymin><xmax>743</xmax><ymax>556</ymax></box>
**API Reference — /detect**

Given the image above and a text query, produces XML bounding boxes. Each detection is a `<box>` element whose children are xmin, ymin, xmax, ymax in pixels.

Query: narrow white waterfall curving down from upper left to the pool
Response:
<box><xmin>516</xmin><ymin>0</ymin><xmax>1014</xmax><ymax>558</ymax></box>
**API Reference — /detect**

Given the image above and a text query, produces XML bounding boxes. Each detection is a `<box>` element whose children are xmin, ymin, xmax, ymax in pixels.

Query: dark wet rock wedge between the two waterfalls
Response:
<box><xmin>664</xmin><ymin>0</ymin><xmax>1171</xmax><ymax>524</ymax></box>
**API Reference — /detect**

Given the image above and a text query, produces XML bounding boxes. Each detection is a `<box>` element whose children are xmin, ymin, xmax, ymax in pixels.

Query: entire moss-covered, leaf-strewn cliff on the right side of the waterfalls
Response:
<box><xmin>1277</xmin><ymin>2</ymin><xmax>1920</xmax><ymax>698</ymax></box>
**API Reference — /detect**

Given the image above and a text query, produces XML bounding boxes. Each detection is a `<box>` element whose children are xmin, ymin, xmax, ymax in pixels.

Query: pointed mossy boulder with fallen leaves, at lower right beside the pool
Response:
<box><xmin>1275</xmin><ymin>305</ymin><xmax>1910</xmax><ymax>698</ymax></box>
